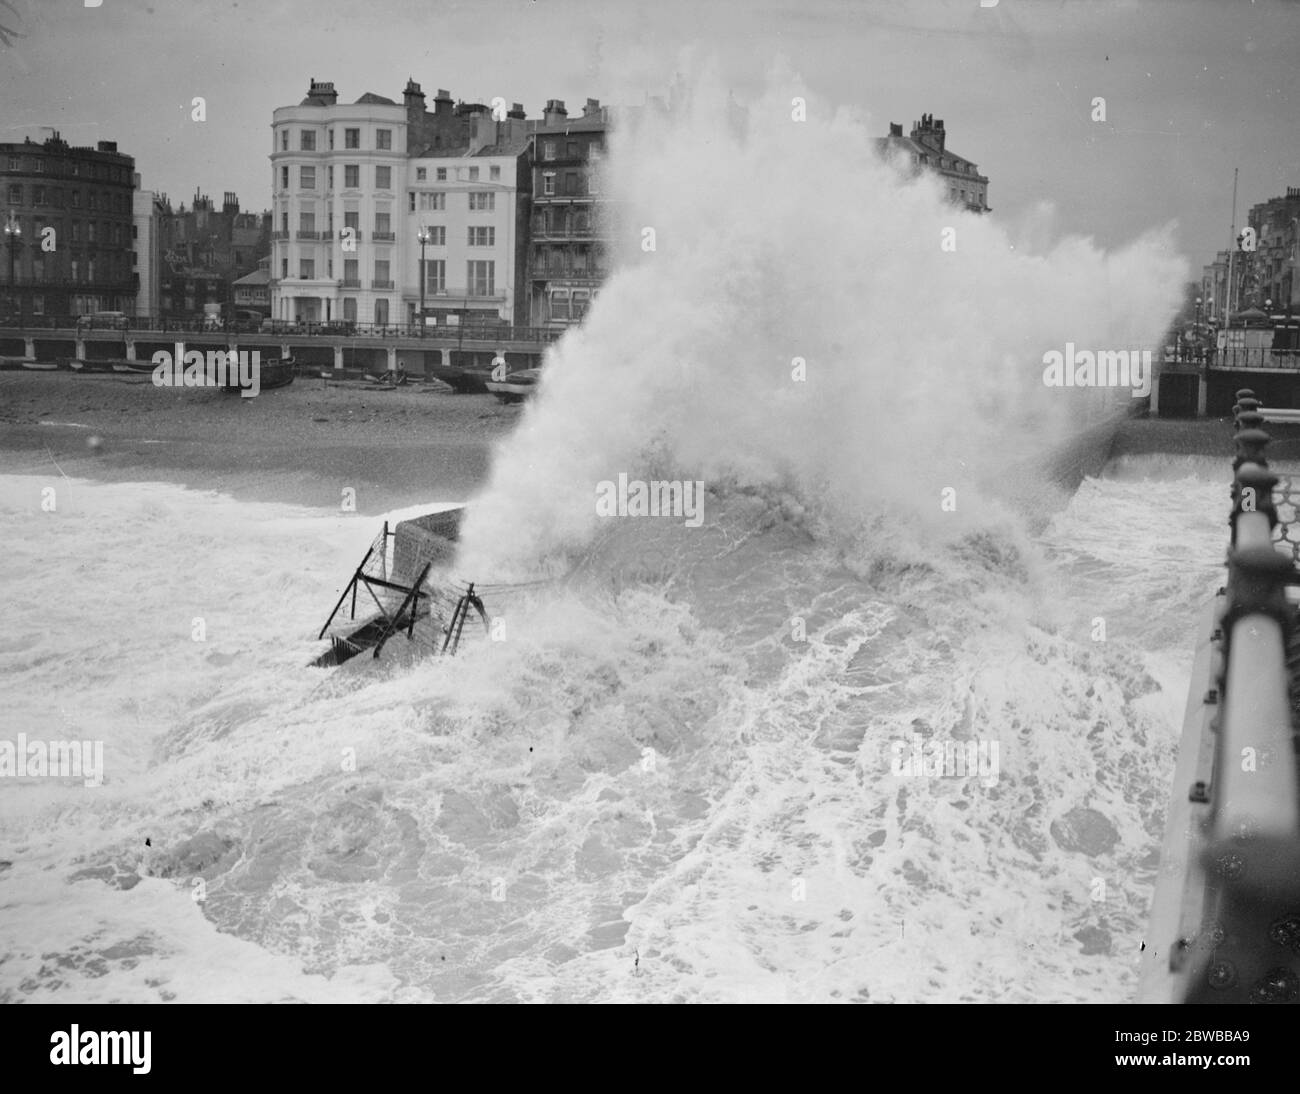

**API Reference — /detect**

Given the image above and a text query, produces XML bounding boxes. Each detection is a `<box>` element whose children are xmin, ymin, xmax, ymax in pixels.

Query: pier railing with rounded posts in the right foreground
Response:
<box><xmin>1151</xmin><ymin>390</ymin><xmax>1300</xmax><ymax>1003</ymax></box>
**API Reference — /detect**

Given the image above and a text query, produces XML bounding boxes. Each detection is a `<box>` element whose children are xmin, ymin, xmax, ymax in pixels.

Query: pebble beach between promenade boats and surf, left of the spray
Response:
<box><xmin>0</xmin><ymin>372</ymin><xmax>521</xmax><ymax>515</ymax></box>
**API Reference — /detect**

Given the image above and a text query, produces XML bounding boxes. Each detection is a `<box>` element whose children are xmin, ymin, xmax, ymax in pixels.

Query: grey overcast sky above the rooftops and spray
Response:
<box><xmin>0</xmin><ymin>0</ymin><xmax>1300</xmax><ymax>268</ymax></box>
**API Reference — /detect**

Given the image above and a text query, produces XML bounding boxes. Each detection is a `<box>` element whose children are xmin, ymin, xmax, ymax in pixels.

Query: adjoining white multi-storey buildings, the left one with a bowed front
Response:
<box><xmin>270</xmin><ymin>81</ymin><xmax>529</xmax><ymax>326</ymax></box>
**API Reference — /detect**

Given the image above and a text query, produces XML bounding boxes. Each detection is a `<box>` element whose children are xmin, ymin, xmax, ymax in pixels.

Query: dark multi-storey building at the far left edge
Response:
<box><xmin>0</xmin><ymin>133</ymin><xmax>137</xmax><ymax>317</ymax></box>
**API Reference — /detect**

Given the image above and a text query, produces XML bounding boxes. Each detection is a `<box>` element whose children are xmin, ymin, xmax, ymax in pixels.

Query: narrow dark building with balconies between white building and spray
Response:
<box><xmin>528</xmin><ymin>99</ymin><xmax>611</xmax><ymax>327</ymax></box>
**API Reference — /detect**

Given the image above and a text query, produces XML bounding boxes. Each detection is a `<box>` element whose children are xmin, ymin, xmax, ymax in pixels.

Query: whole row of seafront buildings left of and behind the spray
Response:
<box><xmin>0</xmin><ymin>92</ymin><xmax>988</xmax><ymax>327</ymax></box>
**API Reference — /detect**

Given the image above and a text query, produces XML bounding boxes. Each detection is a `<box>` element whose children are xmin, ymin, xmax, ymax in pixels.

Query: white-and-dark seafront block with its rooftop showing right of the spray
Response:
<box><xmin>270</xmin><ymin>79</ymin><xmax>988</xmax><ymax>326</ymax></box>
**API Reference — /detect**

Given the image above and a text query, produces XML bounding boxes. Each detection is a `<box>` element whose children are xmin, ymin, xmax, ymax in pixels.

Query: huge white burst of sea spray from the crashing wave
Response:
<box><xmin>462</xmin><ymin>70</ymin><xmax>1184</xmax><ymax>573</ymax></box>
